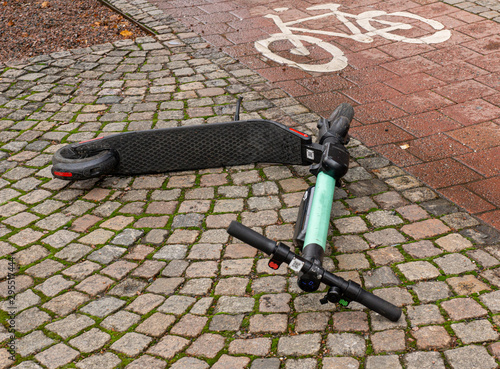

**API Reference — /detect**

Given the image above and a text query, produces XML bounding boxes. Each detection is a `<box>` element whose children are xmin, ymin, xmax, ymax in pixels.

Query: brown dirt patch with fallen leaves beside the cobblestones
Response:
<box><xmin>0</xmin><ymin>0</ymin><xmax>148</xmax><ymax>62</ymax></box>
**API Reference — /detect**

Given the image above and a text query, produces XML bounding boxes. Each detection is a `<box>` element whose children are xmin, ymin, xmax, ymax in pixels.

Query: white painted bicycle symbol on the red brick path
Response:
<box><xmin>255</xmin><ymin>4</ymin><xmax>451</xmax><ymax>72</ymax></box>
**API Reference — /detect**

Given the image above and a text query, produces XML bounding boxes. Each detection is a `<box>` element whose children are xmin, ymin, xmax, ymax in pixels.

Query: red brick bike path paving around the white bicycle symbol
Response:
<box><xmin>150</xmin><ymin>0</ymin><xmax>500</xmax><ymax>229</ymax></box>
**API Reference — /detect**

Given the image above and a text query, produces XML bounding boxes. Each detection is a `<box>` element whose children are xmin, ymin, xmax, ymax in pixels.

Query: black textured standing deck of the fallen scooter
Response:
<box><xmin>54</xmin><ymin>120</ymin><xmax>311</xmax><ymax>175</ymax></box>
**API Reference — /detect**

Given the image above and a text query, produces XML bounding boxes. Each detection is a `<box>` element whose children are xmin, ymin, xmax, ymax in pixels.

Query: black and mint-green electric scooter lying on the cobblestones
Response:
<box><xmin>52</xmin><ymin>99</ymin><xmax>401</xmax><ymax>321</ymax></box>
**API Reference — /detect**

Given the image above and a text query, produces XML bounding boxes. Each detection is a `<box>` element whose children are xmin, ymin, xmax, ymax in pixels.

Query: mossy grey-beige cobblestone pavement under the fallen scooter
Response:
<box><xmin>0</xmin><ymin>1</ymin><xmax>500</xmax><ymax>369</ymax></box>
